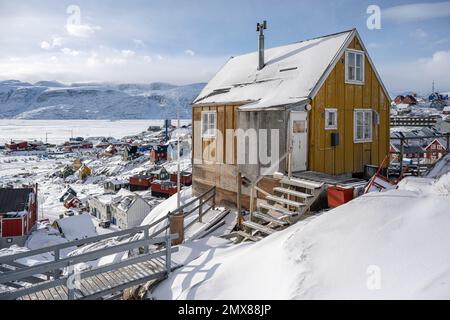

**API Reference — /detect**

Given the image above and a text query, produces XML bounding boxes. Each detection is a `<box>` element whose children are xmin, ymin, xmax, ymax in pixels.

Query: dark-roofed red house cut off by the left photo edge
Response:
<box><xmin>0</xmin><ymin>185</ymin><xmax>38</xmax><ymax>248</ymax></box>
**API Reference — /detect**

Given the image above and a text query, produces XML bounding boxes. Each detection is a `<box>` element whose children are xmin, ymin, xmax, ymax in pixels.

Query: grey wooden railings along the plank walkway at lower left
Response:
<box><xmin>0</xmin><ymin>224</ymin><xmax>178</xmax><ymax>300</ymax></box>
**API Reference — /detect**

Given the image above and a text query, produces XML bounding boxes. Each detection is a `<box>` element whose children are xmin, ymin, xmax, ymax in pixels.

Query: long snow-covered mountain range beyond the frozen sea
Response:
<box><xmin>0</xmin><ymin>80</ymin><xmax>205</xmax><ymax>119</ymax></box>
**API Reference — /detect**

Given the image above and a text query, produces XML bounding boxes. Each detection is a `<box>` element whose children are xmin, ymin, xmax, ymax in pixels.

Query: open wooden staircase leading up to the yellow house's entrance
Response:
<box><xmin>229</xmin><ymin>176</ymin><xmax>324</xmax><ymax>242</ymax></box>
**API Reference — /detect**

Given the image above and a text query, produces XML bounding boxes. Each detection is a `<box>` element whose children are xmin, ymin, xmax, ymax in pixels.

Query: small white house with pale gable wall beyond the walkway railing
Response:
<box><xmin>111</xmin><ymin>189</ymin><xmax>152</xmax><ymax>229</ymax></box>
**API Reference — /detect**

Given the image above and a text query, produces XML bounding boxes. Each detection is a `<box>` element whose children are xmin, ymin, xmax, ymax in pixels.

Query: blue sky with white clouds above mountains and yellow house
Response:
<box><xmin>0</xmin><ymin>0</ymin><xmax>450</xmax><ymax>92</ymax></box>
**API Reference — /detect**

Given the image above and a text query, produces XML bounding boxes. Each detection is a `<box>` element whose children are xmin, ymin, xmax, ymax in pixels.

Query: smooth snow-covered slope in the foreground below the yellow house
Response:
<box><xmin>152</xmin><ymin>173</ymin><xmax>450</xmax><ymax>299</ymax></box>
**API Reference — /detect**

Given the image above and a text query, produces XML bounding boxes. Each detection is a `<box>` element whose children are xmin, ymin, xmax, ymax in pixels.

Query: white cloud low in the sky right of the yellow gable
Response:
<box><xmin>380</xmin><ymin>51</ymin><xmax>450</xmax><ymax>93</ymax></box>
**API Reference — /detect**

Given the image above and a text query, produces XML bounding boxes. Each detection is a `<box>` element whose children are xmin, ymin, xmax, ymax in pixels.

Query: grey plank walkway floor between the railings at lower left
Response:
<box><xmin>18</xmin><ymin>258</ymin><xmax>172</xmax><ymax>300</ymax></box>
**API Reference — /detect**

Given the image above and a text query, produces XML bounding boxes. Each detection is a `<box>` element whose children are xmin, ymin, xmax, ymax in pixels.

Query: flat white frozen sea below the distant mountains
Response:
<box><xmin>0</xmin><ymin>119</ymin><xmax>191</xmax><ymax>144</ymax></box>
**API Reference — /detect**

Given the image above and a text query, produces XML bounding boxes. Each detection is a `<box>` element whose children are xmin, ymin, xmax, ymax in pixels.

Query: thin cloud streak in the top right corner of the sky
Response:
<box><xmin>381</xmin><ymin>1</ymin><xmax>450</xmax><ymax>22</ymax></box>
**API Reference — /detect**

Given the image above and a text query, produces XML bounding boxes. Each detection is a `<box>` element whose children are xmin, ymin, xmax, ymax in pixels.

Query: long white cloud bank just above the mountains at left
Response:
<box><xmin>0</xmin><ymin>48</ymin><xmax>228</xmax><ymax>84</ymax></box>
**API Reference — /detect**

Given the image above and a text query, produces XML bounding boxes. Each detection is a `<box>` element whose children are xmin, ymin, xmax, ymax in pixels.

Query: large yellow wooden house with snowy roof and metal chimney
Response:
<box><xmin>192</xmin><ymin>29</ymin><xmax>390</xmax><ymax>208</ymax></box>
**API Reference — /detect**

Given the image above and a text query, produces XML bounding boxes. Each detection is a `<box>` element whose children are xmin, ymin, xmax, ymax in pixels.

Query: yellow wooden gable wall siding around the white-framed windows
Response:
<box><xmin>308</xmin><ymin>38</ymin><xmax>389</xmax><ymax>174</ymax></box>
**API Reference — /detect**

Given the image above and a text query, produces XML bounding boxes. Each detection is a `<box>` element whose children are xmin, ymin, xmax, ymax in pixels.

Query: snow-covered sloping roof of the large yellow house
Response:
<box><xmin>194</xmin><ymin>30</ymin><xmax>354</xmax><ymax>110</ymax></box>
